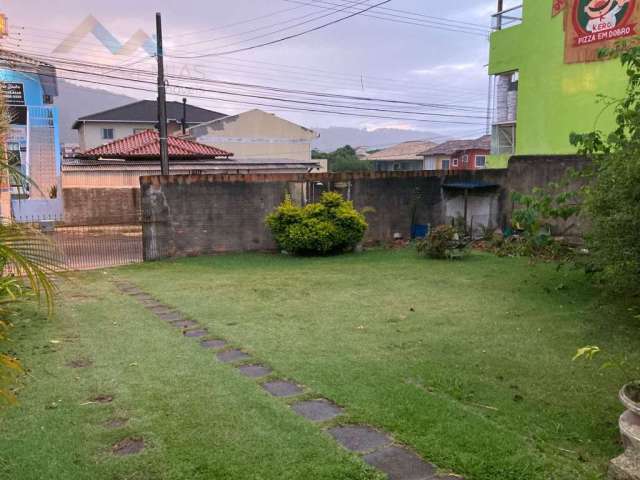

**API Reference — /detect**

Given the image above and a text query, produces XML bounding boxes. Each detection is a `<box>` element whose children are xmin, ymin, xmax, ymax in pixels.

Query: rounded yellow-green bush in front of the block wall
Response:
<box><xmin>266</xmin><ymin>192</ymin><xmax>367</xmax><ymax>255</ymax></box>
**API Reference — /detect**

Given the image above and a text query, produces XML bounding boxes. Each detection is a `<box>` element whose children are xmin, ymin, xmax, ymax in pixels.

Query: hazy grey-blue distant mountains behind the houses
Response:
<box><xmin>56</xmin><ymin>80</ymin><xmax>434</xmax><ymax>152</ymax></box>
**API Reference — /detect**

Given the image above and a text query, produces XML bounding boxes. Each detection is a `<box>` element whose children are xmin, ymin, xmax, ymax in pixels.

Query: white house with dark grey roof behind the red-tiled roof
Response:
<box><xmin>73</xmin><ymin>100</ymin><xmax>226</xmax><ymax>151</ymax></box>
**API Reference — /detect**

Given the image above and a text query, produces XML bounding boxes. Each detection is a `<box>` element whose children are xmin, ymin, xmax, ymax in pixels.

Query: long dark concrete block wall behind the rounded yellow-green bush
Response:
<box><xmin>140</xmin><ymin>170</ymin><xmax>506</xmax><ymax>259</ymax></box>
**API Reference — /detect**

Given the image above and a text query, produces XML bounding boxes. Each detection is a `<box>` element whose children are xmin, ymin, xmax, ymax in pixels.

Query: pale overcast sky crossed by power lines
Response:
<box><xmin>0</xmin><ymin>0</ymin><xmax>510</xmax><ymax>139</ymax></box>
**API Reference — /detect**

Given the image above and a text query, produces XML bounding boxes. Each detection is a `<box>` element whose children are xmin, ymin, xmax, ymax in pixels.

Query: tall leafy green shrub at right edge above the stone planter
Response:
<box><xmin>571</xmin><ymin>42</ymin><xmax>640</xmax><ymax>293</ymax></box>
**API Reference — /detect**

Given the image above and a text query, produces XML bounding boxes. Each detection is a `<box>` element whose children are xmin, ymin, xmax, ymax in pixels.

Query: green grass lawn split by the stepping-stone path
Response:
<box><xmin>0</xmin><ymin>250</ymin><xmax>640</xmax><ymax>480</ymax></box>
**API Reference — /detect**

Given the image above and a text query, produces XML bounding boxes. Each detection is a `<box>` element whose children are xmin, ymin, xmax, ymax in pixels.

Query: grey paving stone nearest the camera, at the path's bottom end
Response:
<box><xmin>364</xmin><ymin>447</ymin><xmax>436</xmax><ymax>480</ymax></box>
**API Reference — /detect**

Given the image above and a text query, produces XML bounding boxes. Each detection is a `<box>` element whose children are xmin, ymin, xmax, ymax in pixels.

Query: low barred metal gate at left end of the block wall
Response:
<box><xmin>16</xmin><ymin>217</ymin><xmax>143</xmax><ymax>270</ymax></box>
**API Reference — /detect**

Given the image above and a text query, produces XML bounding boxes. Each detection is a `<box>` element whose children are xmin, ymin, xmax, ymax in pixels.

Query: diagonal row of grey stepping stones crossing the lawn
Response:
<box><xmin>115</xmin><ymin>282</ymin><xmax>463</xmax><ymax>480</ymax></box>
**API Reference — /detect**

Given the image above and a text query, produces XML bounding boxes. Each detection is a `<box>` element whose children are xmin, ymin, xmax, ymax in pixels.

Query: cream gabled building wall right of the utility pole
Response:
<box><xmin>189</xmin><ymin>110</ymin><xmax>318</xmax><ymax>162</ymax></box>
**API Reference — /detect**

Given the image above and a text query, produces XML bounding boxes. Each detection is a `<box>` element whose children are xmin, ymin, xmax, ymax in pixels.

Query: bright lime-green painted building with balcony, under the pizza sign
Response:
<box><xmin>489</xmin><ymin>0</ymin><xmax>626</xmax><ymax>168</ymax></box>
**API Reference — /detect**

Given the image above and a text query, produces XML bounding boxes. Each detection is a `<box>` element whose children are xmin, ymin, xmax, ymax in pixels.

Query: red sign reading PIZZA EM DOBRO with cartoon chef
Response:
<box><xmin>572</xmin><ymin>0</ymin><xmax>636</xmax><ymax>46</ymax></box>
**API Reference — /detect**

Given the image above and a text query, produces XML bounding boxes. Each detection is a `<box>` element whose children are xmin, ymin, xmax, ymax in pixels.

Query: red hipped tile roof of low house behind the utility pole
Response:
<box><xmin>78</xmin><ymin>130</ymin><xmax>233</xmax><ymax>160</ymax></box>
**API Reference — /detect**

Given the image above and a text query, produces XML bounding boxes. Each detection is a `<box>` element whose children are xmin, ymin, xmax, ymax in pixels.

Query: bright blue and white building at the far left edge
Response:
<box><xmin>0</xmin><ymin>50</ymin><xmax>62</xmax><ymax>220</ymax></box>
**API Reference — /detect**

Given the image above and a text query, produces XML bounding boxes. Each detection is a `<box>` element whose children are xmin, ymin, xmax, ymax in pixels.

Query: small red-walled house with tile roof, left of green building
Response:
<box><xmin>420</xmin><ymin>135</ymin><xmax>491</xmax><ymax>170</ymax></box>
